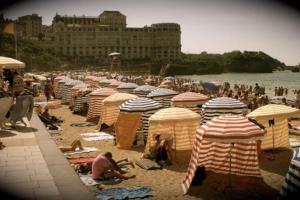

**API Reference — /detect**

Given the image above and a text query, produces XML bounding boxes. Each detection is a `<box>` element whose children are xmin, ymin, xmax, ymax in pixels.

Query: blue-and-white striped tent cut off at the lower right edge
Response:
<box><xmin>280</xmin><ymin>147</ymin><xmax>300</xmax><ymax>199</ymax></box>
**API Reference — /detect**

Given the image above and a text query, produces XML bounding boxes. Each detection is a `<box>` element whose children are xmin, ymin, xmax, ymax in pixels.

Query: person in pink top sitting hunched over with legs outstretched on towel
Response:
<box><xmin>92</xmin><ymin>152</ymin><xmax>135</xmax><ymax>180</ymax></box>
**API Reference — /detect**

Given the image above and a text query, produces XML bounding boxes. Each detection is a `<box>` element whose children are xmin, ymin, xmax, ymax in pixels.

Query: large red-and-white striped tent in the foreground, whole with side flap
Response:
<box><xmin>182</xmin><ymin>115</ymin><xmax>265</xmax><ymax>193</ymax></box>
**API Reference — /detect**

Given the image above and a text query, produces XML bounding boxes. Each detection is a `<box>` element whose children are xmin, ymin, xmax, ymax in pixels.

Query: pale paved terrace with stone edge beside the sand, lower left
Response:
<box><xmin>0</xmin><ymin>113</ymin><xmax>95</xmax><ymax>200</ymax></box>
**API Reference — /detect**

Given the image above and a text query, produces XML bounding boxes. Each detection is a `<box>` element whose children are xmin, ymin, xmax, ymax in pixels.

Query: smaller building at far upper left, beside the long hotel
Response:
<box><xmin>17</xmin><ymin>14</ymin><xmax>42</xmax><ymax>40</ymax></box>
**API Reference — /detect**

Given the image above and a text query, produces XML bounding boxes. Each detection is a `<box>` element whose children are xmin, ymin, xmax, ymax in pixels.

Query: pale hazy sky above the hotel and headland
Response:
<box><xmin>1</xmin><ymin>0</ymin><xmax>300</xmax><ymax>65</ymax></box>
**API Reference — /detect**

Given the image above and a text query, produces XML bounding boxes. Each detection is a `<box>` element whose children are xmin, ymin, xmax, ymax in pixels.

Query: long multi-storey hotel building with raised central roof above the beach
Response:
<box><xmin>49</xmin><ymin>11</ymin><xmax>181</xmax><ymax>62</ymax></box>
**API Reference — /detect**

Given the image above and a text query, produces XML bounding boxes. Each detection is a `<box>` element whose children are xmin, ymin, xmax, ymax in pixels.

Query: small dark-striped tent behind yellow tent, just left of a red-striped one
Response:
<box><xmin>147</xmin><ymin>88</ymin><xmax>178</xmax><ymax>108</ymax></box>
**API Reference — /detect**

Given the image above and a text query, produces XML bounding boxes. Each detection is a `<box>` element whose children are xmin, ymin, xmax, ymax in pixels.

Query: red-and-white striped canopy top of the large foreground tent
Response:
<box><xmin>202</xmin><ymin>115</ymin><xmax>265</xmax><ymax>143</ymax></box>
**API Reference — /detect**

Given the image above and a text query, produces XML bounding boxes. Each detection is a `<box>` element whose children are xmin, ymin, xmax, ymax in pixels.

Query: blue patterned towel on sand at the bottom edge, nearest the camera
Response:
<box><xmin>96</xmin><ymin>187</ymin><xmax>154</xmax><ymax>200</ymax></box>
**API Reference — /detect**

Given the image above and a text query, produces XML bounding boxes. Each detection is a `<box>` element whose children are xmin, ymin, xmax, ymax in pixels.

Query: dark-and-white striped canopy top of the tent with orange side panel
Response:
<box><xmin>120</xmin><ymin>97</ymin><xmax>163</xmax><ymax>112</ymax></box>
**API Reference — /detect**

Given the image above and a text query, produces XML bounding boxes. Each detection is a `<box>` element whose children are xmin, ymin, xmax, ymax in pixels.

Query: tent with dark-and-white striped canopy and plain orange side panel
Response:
<box><xmin>115</xmin><ymin>97</ymin><xmax>163</xmax><ymax>149</ymax></box>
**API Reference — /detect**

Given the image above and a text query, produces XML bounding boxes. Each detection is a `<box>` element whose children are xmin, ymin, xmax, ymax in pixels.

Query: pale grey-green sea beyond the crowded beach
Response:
<box><xmin>176</xmin><ymin>70</ymin><xmax>300</xmax><ymax>98</ymax></box>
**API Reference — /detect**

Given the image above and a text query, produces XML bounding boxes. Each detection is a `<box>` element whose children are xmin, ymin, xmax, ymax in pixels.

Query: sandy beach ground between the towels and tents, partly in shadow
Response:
<box><xmin>50</xmin><ymin>105</ymin><xmax>292</xmax><ymax>200</ymax></box>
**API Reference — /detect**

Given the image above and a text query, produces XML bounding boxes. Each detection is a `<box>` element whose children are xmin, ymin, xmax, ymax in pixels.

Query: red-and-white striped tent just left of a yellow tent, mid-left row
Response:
<box><xmin>87</xmin><ymin>88</ymin><xmax>116</xmax><ymax>120</ymax></box>
